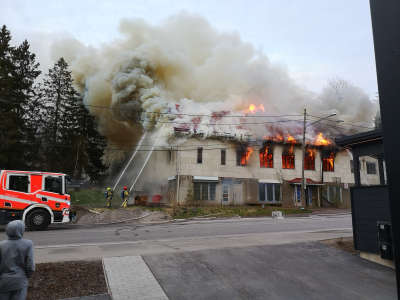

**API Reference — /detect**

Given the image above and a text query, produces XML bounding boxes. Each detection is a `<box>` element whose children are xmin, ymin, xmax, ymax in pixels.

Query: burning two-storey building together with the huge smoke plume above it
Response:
<box><xmin>55</xmin><ymin>13</ymin><xmax>376</xmax><ymax>206</ymax></box>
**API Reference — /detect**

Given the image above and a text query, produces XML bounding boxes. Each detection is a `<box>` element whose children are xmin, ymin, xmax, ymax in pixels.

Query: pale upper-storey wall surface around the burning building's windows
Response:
<box><xmin>136</xmin><ymin>138</ymin><xmax>379</xmax><ymax>193</ymax></box>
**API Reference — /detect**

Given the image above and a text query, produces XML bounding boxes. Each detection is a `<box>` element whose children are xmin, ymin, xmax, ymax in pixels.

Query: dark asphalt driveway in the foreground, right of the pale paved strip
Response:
<box><xmin>143</xmin><ymin>242</ymin><xmax>396</xmax><ymax>300</ymax></box>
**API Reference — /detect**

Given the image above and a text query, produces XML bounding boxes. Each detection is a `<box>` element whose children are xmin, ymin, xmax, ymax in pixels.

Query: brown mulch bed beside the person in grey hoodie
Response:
<box><xmin>27</xmin><ymin>260</ymin><xmax>107</xmax><ymax>300</ymax></box>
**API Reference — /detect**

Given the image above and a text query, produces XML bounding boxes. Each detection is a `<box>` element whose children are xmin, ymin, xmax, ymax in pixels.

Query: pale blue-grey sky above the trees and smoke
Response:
<box><xmin>0</xmin><ymin>0</ymin><xmax>378</xmax><ymax>98</ymax></box>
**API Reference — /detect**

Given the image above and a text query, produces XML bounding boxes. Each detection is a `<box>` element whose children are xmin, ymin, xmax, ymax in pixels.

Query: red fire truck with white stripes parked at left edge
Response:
<box><xmin>0</xmin><ymin>170</ymin><xmax>71</xmax><ymax>230</ymax></box>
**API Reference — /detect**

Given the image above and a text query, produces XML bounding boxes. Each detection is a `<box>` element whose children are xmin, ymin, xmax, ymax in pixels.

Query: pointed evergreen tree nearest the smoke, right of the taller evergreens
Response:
<box><xmin>41</xmin><ymin>58</ymin><xmax>105</xmax><ymax>180</ymax></box>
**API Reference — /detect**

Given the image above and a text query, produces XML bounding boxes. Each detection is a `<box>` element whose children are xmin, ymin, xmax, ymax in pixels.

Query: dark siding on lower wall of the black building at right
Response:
<box><xmin>351</xmin><ymin>186</ymin><xmax>390</xmax><ymax>253</ymax></box>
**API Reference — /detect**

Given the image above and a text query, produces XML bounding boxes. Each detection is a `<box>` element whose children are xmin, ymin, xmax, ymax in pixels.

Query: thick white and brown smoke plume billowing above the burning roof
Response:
<box><xmin>55</xmin><ymin>14</ymin><xmax>376</xmax><ymax>161</ymax></box>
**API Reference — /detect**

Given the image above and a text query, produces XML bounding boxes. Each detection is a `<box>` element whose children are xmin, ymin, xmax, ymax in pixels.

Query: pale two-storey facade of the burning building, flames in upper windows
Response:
<box><xmin>134</xmin><ymin>138</ymin><xmax>379</xmax><ymax>208</ymax></box>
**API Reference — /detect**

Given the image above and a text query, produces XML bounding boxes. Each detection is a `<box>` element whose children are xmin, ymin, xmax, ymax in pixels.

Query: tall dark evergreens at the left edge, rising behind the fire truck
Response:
<box><xmin>0</xmin><ymin>25</ymin><xmax>40</xmax><ymax>169</ymax></box>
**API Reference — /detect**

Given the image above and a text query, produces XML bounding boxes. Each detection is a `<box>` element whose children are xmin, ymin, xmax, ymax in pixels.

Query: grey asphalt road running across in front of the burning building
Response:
<box><xmin>0</xmin><ymin>214</ymin><xmax>351</xmax><ymax>246</ymax></box>
